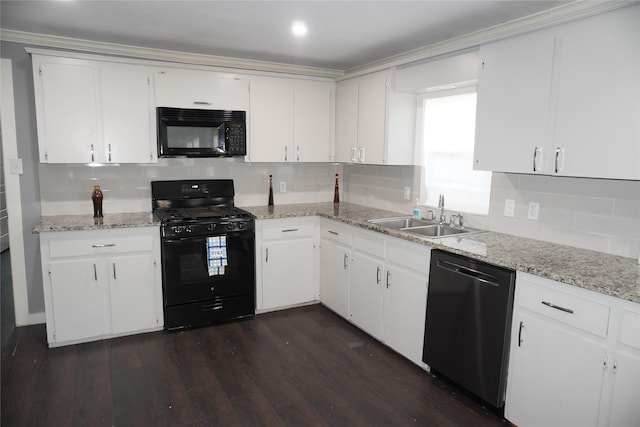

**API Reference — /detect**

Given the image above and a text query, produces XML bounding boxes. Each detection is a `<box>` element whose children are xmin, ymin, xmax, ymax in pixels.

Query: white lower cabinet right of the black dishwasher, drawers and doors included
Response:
<box><xmin>505</xmin><ymin>272</ymin><xmax>640</xmax><ymax>427</ymax></box>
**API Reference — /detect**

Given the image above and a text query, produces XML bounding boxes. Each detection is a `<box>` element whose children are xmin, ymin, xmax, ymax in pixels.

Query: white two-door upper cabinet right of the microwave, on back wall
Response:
<box><xmin>248</xmin><ymin>77</ymin><xmax>334</xmax><ymax>162</ymax></box>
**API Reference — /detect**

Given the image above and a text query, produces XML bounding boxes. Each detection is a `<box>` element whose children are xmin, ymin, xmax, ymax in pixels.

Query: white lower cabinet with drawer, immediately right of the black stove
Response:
<box><xmin>256</xmin><ymin>218</ymin><xmax>318</xmax><ymax>311</ymax></box>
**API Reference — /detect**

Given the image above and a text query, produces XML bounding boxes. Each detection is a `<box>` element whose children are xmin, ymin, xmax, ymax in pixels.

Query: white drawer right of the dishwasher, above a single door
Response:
<box><xmin>516</xmin><ymin>280</ymin><xmax>610</xmax><ymax>338</ymax></box>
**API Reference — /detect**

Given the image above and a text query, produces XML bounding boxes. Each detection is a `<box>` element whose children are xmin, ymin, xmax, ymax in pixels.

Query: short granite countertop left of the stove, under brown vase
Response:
<box><xmin>31</xmin><ymin>212</ymin><xmax>160</xmax><ymax>233</ymax></box>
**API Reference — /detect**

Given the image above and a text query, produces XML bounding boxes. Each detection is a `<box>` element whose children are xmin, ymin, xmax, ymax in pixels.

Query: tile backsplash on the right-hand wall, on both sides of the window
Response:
<box><xmin>344</xmin><ymin>165</ymin><xmax>640</xmax><ymax>259</ymax></box>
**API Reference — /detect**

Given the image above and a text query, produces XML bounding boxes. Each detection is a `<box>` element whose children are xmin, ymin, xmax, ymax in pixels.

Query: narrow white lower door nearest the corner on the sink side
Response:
<box><xmin>320</xmin><ymin>239</ymin><xmax>351</xmax><ymax>319</ymax></box>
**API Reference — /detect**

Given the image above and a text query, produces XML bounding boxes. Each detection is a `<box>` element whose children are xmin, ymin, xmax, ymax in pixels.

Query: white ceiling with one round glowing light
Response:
<box><xmin>0</xmin><ymin>0</ymin><xmax>570</xmax><ymax>71</ymax></box>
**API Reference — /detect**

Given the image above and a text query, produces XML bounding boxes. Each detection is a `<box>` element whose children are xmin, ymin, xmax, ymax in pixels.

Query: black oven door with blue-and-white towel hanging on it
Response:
<box><xmin>162</xmin><ymin>230</ymin><xmax>255</xmax><ymax>306</ymax></box>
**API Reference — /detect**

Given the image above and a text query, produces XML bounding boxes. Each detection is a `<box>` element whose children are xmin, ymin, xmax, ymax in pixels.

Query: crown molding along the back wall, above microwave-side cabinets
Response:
<box><xmin>0</xmin><ymin>28</ymin><xmax>343</xmax><ymax>79</ymax></box>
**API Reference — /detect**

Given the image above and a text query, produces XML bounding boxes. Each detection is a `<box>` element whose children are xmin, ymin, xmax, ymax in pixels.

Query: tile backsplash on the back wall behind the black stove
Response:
<box><xmin>39</xmin><ymin>158</ymin><xmax>342</xmax><ymax>215</ymax></box>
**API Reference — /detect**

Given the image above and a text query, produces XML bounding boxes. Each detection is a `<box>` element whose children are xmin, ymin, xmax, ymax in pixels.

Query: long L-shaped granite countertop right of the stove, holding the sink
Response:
<box><xmin>243</xmin><ymin>203</ymin><xmax>640</xmax><ymax>303</ymax></box>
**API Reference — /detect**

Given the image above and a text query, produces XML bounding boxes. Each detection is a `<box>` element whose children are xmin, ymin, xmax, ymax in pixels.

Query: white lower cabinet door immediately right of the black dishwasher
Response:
<box><xmin>505</xmin><ymin>312</ymin><xmax>606</xmax><ymax>427</ymax></box>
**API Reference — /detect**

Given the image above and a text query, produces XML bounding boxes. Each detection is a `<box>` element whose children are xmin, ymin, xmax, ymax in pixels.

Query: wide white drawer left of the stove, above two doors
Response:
<box><xmin>49</xmin><ymin>235</ymin><xmax>153</xmax><ymax>258</ymax></box>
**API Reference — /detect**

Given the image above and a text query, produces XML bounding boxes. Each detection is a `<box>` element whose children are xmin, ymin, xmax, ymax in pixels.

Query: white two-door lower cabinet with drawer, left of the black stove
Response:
<box><xmin>40</xmin><ymin>227</ymin><xmax>163</xmax><ymax>347</ymax></box>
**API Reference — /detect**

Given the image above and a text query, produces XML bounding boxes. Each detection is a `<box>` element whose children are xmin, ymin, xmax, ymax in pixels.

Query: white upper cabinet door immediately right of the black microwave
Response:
<box><xmin>249</xmin><ymin>78</ymin><xmax>296</xmax><ymax>162</ymax></box>
